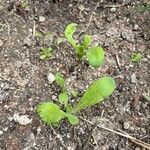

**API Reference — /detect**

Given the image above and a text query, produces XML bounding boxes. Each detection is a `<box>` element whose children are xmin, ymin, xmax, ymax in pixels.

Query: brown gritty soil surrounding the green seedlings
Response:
<box><xmin>0</xmin><ymin>0</ymin><xmax>150</xmax><ymax>150</ymax></box>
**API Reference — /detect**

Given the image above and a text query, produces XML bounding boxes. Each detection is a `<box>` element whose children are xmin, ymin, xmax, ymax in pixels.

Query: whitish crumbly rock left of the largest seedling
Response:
<box><xmin>13</xmin><ymin>114</ymin><xmax>32</xmax><ymax>125</ymax></box>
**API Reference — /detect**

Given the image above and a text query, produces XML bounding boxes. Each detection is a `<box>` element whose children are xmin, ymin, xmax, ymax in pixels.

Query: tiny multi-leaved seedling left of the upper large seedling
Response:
<box><xmin>40</xmin><ymin>47</ymin><xmax>52</xmax><ymax>60</ymax></box>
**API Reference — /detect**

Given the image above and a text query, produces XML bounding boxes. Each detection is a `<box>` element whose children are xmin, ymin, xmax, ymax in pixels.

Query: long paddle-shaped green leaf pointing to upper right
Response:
<box><xmin>73</xmin><ymin>77</ymin><xmax>116</xmax><ymax>112</ymax></box>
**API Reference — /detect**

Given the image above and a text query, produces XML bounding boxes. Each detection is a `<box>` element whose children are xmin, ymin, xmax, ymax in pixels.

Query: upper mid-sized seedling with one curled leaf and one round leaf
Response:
<box><xmin>65</xmin><ymin>23</ymin><xmax>104</xmax><ymax>68</ymax></box>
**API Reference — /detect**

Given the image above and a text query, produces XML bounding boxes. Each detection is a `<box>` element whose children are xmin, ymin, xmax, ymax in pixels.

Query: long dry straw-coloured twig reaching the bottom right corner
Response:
<box><xmin>80</xmin><ymin>117</ymin><xmax>150</xmax><ymax>150</ymax></box>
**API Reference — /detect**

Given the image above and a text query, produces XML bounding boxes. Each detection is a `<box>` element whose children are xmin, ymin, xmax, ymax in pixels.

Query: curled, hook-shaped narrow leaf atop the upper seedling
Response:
<box><xmin>65</xmin><ymin>23</ymin><xmax>77</xmax><ymax>49</ymax></box>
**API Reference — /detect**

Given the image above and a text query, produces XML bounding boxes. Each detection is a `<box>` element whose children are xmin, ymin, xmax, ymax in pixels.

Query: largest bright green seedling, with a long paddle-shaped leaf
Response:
<box><xmin>37</xmin><ymin>77</ymin><xmax>116</xmax><ymax>125</ymax></box>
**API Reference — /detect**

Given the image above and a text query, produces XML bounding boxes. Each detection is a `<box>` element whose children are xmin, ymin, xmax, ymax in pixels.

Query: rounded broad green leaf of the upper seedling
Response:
<box><xmin>86</xmin><ymin>47</ymin><xmax>104</xmax><ymax>68</ymax></box>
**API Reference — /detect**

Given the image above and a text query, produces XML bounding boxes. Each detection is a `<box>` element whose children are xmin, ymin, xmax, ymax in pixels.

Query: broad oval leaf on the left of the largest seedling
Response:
<box><xmin>36</xmin><ymin>102</ymin><xmax>66</xmax><ymax>124</ymax></box>
